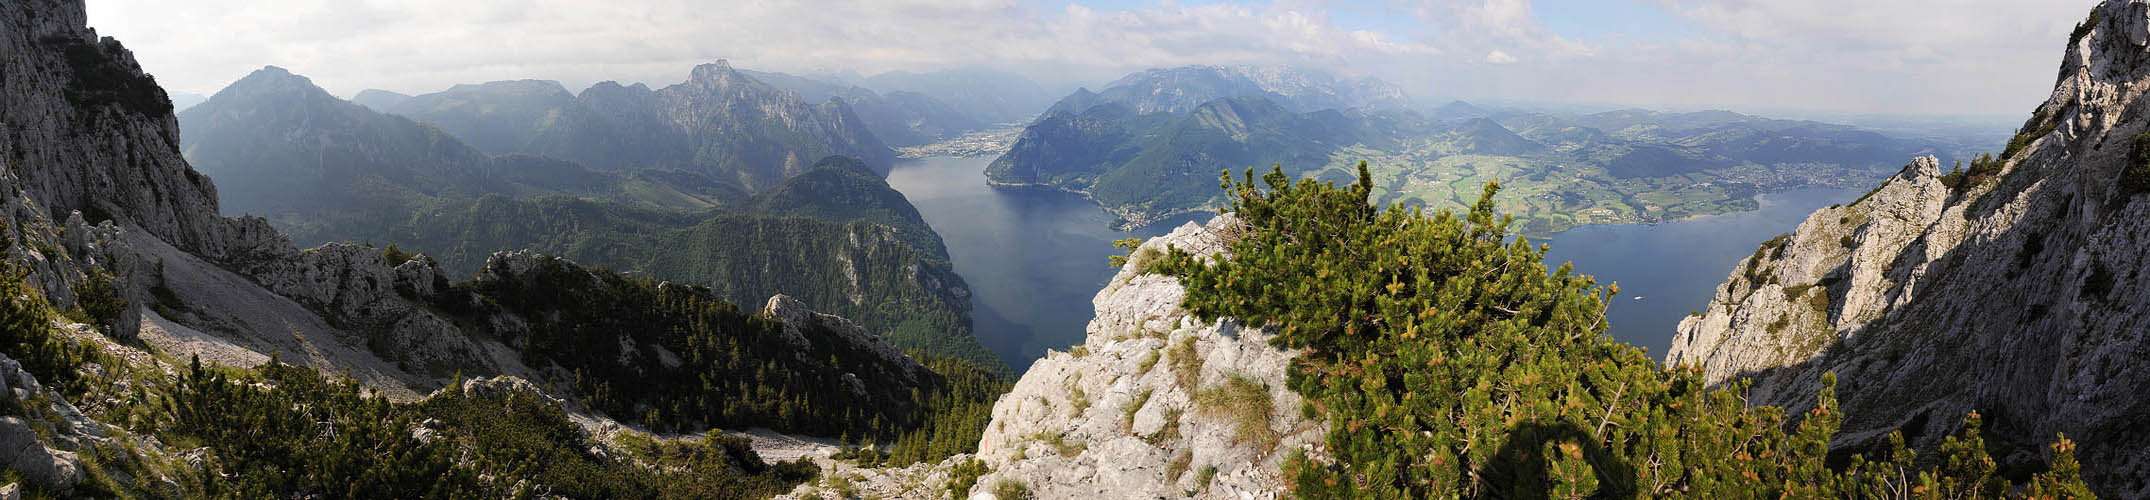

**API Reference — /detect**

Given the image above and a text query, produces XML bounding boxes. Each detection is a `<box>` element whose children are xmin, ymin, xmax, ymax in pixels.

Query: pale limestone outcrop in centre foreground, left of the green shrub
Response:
<box><xmin>974</xmin><ymin>215</ymin><xmax>1327</xmax><ymax>498</ymax></box>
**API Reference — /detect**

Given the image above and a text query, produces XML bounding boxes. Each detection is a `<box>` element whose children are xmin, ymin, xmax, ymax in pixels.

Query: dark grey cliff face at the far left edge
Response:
<box><xmin>0</xmin><ymin>0</ymin><xmax>228</xmax><ymax>253</ymax></box>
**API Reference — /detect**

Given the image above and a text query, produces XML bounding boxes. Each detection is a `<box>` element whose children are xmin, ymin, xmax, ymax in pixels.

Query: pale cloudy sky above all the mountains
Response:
<box><xmin>88</xmin><ymin>0</ymin><xmax>2094</xmax><ymax>116</ymax></box>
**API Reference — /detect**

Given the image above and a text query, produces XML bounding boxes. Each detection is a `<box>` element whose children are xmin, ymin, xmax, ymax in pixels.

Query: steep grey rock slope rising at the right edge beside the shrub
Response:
<box><xmin>1666</xmin><ymin>0</ymin><xmax>2150</xmax><ymax>498</ymax></box>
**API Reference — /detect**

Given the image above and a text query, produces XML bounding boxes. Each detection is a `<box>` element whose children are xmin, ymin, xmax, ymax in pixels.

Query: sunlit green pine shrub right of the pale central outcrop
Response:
<box><xmin>1155</xmin><ymin>163</ymin><xmax>2081</xmax><ymax>498</ymax></box>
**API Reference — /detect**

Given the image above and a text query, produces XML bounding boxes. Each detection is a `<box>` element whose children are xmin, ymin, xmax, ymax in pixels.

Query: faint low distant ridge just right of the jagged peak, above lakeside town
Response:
<box><xmin>740</xmin><ymin>71</ymin><xmax>989</xmax><ymax>146</ymax></box>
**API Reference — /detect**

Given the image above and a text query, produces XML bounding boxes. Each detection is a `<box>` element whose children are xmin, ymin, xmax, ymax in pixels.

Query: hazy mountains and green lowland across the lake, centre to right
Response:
<box><xmin>987</xmin><ymin>67</ymin><xmax>1976</xmax><ymax>236</ymax></box>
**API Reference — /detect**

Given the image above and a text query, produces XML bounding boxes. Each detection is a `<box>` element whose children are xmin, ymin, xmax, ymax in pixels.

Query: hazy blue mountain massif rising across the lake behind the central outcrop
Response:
<box><xmin>987</xmin><ymin>67</ymin><xmax>1432</xmax><ymax>223</ymax></box>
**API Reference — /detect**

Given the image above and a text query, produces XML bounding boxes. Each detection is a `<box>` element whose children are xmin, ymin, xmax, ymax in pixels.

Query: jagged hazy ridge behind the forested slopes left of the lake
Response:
<box><xmin>368</xmin><ymin>60</ymin><xmax>894</xmax><ymax>189</ymax></box>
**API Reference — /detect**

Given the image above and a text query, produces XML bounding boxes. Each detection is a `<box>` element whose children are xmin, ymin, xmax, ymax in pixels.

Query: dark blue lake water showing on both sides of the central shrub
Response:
<box><xmin>888</xmin><ymin>159</ymin><xmax>1858</xmax><ymax>371</ymax></box>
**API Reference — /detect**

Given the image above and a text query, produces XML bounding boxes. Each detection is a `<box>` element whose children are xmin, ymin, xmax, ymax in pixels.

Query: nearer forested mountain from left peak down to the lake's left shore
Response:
<box><xmin>178</xmin><ymin>67</ymin><xmax>1002</xmax><ymax>367</ymax></box>
